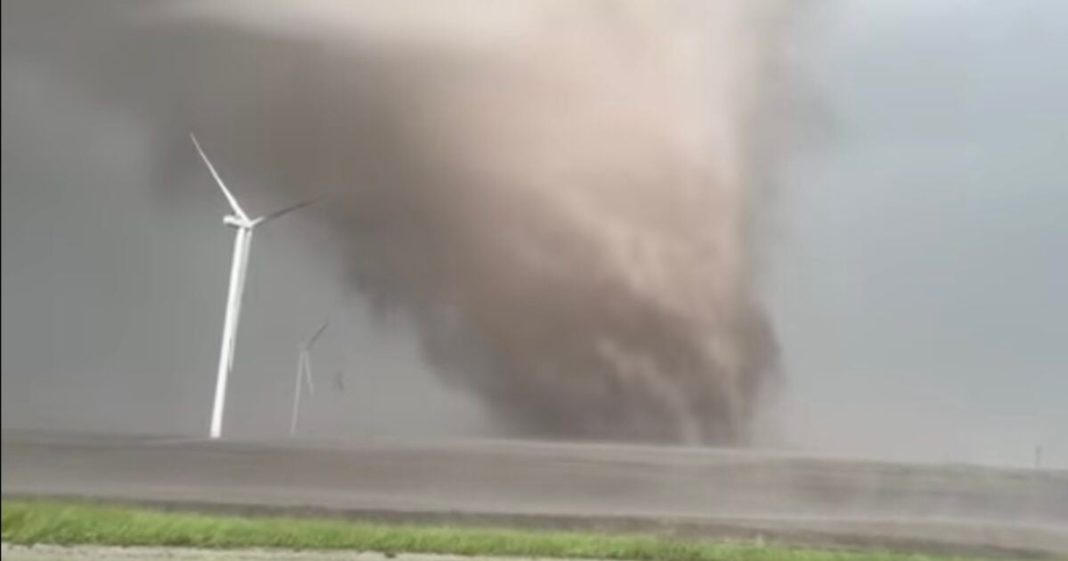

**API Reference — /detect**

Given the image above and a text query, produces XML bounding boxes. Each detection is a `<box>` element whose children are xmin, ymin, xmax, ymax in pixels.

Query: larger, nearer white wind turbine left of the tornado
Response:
<box><xmin>189</xmin><ymin>134</ymin><xmax>315</xmax><ymax>438</ymax></box>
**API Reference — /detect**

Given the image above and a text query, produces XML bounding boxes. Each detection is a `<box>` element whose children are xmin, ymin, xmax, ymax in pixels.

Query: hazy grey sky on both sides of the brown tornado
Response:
<box><xmin>2</xmin><ymin>0</ymin><xmax>1068</xmax><ymax>467</ymax></box>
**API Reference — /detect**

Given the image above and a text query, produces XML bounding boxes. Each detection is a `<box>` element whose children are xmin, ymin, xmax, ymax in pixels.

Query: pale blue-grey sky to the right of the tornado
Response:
<box><xmin>772</xmin><ymin>0</ymin><xmax>1068</xmax><ymax>466</ymax></box>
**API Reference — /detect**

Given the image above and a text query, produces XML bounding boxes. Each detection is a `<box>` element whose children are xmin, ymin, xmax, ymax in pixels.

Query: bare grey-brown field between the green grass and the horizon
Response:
<box><xmin>2</xmin><ymin>433</ymin><xmax>1068</xmax><ymax>555</ymax></box>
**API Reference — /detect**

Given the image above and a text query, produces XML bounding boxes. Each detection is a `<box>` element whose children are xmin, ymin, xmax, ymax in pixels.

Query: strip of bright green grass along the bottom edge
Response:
<box><xmin>3</xmin><ymin>500</ymin><xmax>986</xmax><ymax>561</ymax></box>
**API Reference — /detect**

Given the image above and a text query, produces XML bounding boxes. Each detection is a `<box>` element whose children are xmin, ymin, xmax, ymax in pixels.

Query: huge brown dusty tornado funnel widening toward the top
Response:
<box><xmin>5</xmin><ymin>0</ymin><xmax>784</xmax><ymax>443</ymax></box>
